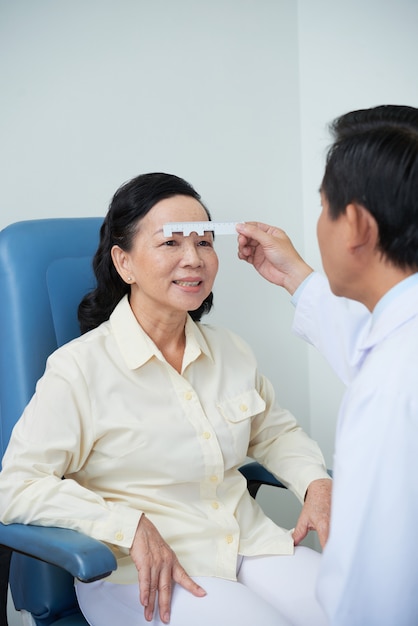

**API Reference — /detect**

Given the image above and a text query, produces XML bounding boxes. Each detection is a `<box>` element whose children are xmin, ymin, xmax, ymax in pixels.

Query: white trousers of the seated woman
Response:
<box><xmin>76</xmin><ymin>546</ymin><xmax>327</xmax><ymax>626</ymax></box>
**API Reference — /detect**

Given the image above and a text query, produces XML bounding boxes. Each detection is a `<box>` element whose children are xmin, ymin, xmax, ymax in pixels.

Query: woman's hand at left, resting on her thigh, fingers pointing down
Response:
<box><xmin>130</xmin><ymin>515</ymin><xmax>206</xmax><ymax>624</ymax></box>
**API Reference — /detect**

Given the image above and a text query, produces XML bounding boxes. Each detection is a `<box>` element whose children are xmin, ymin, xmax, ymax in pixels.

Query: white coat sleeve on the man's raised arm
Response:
<box><xmin>292</xmin><ymin>272</ymin><xmax>371</xmax><ymax>385</ymax></box>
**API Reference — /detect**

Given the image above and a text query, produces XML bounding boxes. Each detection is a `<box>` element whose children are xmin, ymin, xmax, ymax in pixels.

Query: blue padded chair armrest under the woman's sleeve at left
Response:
<box><xmin>0</xmin><ymin>524</ymin><xmax>117</xmax><ymax>582</ymax></box>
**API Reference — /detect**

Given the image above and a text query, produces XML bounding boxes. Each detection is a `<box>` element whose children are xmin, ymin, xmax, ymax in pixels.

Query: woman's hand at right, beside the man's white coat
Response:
<box><xmin>293</xmin><ymin>478</ymin><xmax>332</xmax><ymax>548</ymax></box>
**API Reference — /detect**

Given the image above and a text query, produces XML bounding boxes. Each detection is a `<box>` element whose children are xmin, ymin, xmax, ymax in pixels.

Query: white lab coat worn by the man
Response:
<box><xmin>293</xmin><ymin>274</ymin><xmax>418</xmax><ymax>626</ymax></box>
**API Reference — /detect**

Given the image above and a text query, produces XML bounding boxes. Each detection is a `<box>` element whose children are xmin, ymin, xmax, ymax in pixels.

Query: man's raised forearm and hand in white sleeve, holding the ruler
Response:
<box><xmin>237</xmin><ymin>222</ymin><xmax>370</xmax><ymax>384</ymax></box>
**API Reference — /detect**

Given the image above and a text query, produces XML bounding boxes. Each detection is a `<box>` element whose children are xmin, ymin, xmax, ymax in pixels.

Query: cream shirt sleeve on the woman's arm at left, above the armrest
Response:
<box><xmin>0</xmin><ymin>353</ymin><xmax>142</xmax><ymax>548</ymax></box>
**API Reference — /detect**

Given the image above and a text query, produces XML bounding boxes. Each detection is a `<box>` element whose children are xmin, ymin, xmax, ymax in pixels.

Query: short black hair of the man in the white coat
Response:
<box><xmin>321</xmin><ymin>105</ymin><xmax>418</xmax><ymax>270</ymax></box>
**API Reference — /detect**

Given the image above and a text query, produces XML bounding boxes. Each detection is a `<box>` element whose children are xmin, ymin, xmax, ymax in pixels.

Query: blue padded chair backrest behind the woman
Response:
<box><xmin>0</xmin><ymin>218</ymin><xmax>103</xmax><ymax>624</ymax></box>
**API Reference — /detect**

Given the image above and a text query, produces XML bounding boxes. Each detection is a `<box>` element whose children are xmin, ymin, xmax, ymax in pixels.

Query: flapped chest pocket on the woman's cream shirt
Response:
<box><xmin>217</xmin><ymin>389</ymin><xmax>266</xmax><ymax>463</ymax></box>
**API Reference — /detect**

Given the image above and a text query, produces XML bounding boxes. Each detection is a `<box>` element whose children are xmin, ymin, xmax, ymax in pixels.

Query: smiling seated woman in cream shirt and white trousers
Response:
<box><xmin>0</xmin><ymin>174</ymin><xmax>331</xmax><ymax>626</ymax></box>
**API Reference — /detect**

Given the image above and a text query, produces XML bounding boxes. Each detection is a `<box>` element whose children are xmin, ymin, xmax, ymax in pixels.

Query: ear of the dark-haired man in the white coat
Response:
<box><xmin>345</xmin><ymin>202</ymin><xmax>379</xmax><ymax>254</ymax></box>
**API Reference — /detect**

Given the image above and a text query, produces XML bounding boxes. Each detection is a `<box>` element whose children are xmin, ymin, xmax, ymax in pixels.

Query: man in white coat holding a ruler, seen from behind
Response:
<box><xmin>237</xmin><ymin>105</ymin><xmax>418</xmax><ymax>626</ymax></box>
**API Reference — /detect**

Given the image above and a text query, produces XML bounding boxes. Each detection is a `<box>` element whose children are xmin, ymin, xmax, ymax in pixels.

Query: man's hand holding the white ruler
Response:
<box><xmin>236</xmin><ymin>222</ymin><xmax>313</xmax><ymax>294</ymax></box>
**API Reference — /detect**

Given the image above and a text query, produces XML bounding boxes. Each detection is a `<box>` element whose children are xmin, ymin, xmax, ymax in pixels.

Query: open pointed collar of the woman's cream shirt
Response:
<box><xmin>109</xmin><ymin>296</ymin><xmax>212</xmax><ymax>370</ymax></box>
